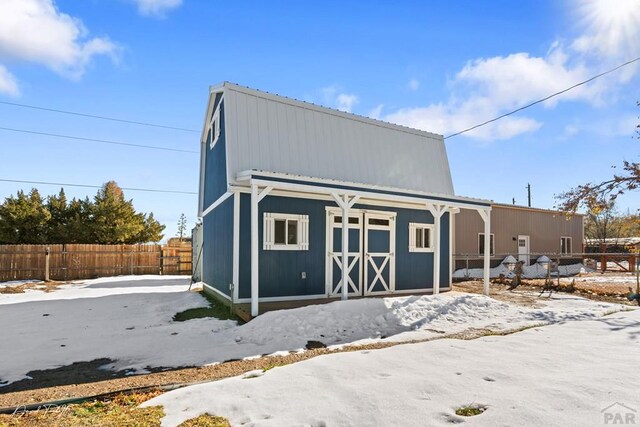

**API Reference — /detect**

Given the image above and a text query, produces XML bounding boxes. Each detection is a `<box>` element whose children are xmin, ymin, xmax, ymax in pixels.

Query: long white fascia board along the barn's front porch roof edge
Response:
<box><xmin>236</xmin><ymin>170</ymin><xmax>492</xmax><ymax>211</ymax></box>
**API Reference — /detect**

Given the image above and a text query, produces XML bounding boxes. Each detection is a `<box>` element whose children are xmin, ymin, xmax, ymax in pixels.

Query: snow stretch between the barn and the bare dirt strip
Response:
<box><xmin>0</xmin><ymin>276</ymin><xmax>622</xmax><ymax>390</ymax></box>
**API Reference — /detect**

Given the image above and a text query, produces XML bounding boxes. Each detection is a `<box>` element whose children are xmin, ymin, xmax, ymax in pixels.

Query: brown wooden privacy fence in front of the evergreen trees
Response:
<box><xmin>0</xmin><ymin>244</ymin><xmax>191</xmax><ymax>282</ymax></box>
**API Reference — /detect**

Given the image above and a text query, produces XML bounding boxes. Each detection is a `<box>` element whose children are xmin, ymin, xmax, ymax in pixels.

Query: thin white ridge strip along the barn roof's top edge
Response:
<box><xmin>218</xmin><ymin>82</ymin><xmax>444</xmax><ymax>141</ymax></box>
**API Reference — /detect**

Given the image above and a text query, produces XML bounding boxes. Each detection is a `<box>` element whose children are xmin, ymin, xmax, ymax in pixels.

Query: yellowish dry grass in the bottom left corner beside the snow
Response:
<box><xmin>0</xmin><ymin>390</ymin><xmax>230</xmax><ymax>427</ymax></box>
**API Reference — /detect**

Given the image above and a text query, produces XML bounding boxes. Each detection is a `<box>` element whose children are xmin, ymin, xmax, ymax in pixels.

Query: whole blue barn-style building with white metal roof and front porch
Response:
<box><xmin>194</xmin><ymin>83</ymin><xmax>491</xmax><ymax>316</ymax></box>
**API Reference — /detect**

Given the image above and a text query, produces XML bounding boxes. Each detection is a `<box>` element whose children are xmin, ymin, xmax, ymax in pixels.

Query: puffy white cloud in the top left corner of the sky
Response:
<box><xmin>0</xmin><ymin>0</ymin><xmax>118</xmax><ymax>86</ymax></box>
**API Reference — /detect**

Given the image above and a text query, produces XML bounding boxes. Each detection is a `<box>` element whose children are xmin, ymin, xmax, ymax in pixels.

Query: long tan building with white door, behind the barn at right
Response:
<box><xmin>453</xmin><ymin>203</ymin><xmax>584</xmax><ymax>268</ymax></box>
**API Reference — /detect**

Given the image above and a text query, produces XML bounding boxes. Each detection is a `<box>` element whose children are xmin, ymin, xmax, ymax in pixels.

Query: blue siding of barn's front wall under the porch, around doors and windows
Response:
<box><xmin>239</xmin><ymin>194</ymin><xmax>450</xmax><ymax>298</ymax></box>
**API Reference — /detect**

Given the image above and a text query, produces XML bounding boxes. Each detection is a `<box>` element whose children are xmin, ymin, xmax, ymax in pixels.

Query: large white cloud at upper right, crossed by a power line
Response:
<box><xmin>385</xmin><ymin>0</ymin><xmax>640</xmax><ymax>140</ymax></box>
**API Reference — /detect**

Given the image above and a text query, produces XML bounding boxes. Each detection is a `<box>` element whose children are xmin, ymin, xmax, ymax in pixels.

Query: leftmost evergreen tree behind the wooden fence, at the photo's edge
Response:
<box><xmin>0</xmin><ymin>188</ymin><xmax>51</xmax><ymax>244</ymax></box>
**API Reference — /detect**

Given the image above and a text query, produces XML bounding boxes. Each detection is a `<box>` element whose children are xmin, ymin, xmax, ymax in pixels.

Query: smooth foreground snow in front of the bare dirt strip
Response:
<box><xmin>143</xmin><ymin>310</ymin><xmax>640</xmax><ymax>426</ymax></box>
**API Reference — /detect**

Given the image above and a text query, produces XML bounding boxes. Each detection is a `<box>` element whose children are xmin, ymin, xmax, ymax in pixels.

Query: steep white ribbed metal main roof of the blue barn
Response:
<box><xmin>210</xmin><ymin>83</ymin><xmax>454</xmax><ymax>195</ymax></box>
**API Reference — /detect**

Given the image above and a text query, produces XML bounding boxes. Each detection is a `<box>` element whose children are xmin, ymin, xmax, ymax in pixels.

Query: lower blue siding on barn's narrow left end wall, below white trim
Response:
<box><xmin>202</xmin><ymin>197</ymin><xmax>234</xmax><ymax>295</ymax></box>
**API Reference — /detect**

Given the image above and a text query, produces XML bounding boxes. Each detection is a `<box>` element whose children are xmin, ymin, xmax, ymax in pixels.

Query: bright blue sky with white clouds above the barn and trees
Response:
<box><xmin>0</xmin><ymin>0</ymin><xmax>640</xmax><ymax>236</ymax></box>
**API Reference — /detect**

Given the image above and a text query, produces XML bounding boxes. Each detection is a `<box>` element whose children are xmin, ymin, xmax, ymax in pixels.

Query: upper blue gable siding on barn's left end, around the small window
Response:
<box><xmin>203</xmin><ymin>94</ymin><xmax>227</xmax><ymax>209</ymax></box>
